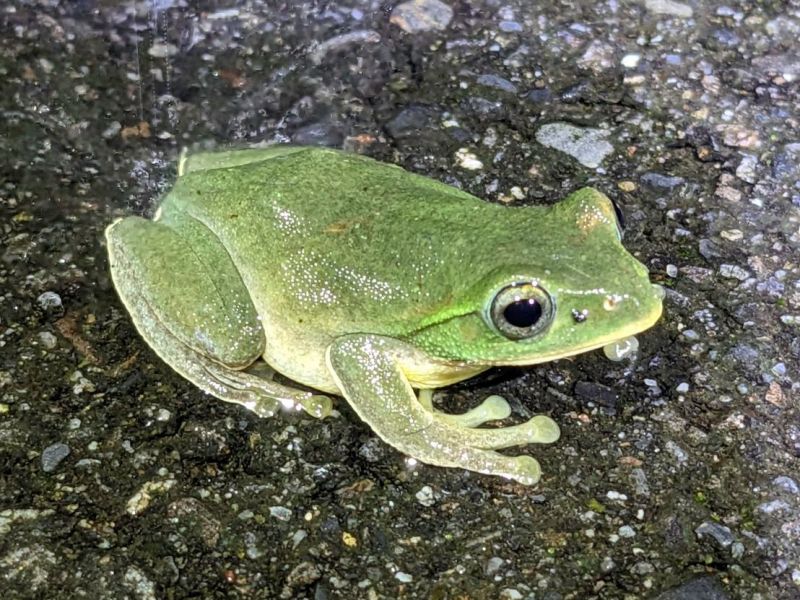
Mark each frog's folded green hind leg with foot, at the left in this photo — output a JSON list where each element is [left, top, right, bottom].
[[106, 215, 330, 416]]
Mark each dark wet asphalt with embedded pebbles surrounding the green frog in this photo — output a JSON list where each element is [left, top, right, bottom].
[[0, 0, 800, 600]]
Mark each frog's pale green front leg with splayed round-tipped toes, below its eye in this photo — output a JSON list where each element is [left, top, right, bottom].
[[327, 334, 558, 485]]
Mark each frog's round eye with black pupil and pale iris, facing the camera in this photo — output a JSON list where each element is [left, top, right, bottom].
[[489, 281, 553, 340]]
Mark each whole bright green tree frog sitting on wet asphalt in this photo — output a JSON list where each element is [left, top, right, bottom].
[[106, 146, 662, 484]]
